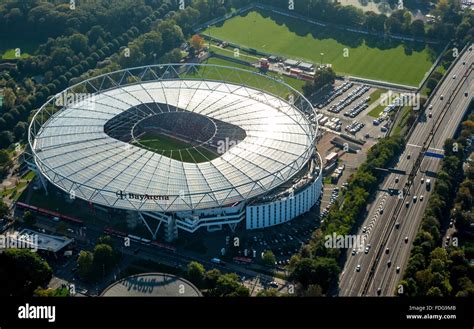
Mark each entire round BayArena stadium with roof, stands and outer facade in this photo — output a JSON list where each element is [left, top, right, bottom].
[[28, 64, 322, 241]]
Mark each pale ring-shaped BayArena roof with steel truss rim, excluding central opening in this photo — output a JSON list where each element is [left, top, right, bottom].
[[28, 64, 317, 212]]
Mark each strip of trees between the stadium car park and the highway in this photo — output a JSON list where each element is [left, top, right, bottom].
[[289, 136, 404, 294]]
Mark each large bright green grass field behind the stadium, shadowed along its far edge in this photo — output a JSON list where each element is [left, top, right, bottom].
[[203, 11, 443, 86]]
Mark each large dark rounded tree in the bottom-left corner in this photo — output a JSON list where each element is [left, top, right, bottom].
[[0, 249, 53, 297]]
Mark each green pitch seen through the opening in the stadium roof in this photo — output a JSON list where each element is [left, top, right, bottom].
[[134, 134, 219, 163]]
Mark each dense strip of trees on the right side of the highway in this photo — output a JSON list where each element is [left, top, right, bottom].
[[399, 114, 474, 296]]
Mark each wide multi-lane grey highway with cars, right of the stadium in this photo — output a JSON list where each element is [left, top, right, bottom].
[[339, 42, 474, 296]]
